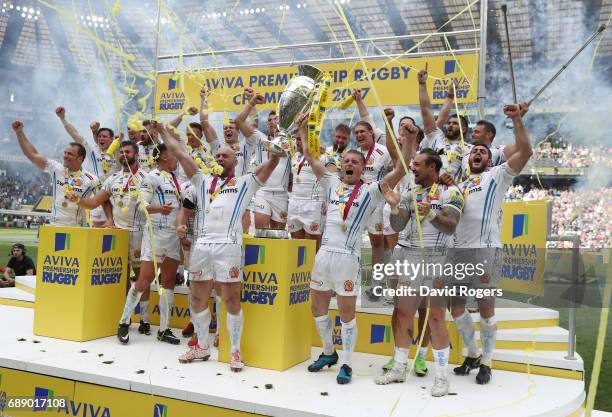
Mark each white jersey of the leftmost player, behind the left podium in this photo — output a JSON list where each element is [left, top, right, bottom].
[[44, 159, 100, 226]]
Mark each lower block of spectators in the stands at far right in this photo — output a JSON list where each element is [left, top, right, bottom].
[[506, 185, 612, 249]]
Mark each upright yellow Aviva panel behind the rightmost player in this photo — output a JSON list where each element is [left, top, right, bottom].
[[500, 200, 548, 296]]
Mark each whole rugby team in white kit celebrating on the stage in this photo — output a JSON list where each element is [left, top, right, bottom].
[[12, 69, 532, 396]]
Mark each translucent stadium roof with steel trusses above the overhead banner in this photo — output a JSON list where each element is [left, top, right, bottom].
[[0, 0, 612, 75]]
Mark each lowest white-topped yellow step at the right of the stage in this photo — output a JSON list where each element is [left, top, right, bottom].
[[462, 348, 584, 380]]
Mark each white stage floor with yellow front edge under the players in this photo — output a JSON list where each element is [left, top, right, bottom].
[[0, 302, 584, 417]]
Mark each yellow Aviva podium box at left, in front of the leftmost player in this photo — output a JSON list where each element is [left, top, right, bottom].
[[34, 226, 129, 341]]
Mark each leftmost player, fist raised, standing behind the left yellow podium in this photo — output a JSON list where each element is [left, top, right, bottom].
[[12, 120, 100, 226]]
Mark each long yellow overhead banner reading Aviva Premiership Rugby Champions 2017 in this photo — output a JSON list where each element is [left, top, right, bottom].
[[155, 54, 478, 114]]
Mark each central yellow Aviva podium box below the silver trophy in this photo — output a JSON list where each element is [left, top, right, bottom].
[[219, 238, 316, 371]]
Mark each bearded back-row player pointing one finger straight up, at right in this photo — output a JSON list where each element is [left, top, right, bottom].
[[417, 64, 468, 185]]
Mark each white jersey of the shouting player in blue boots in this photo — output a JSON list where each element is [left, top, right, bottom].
[[319, 172, 384, 256]]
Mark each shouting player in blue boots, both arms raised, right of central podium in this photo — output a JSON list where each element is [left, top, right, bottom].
[[299, 117, 417, 384]]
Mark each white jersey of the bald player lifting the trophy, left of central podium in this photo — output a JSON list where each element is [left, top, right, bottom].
[[191, 172, 263, 244]]
